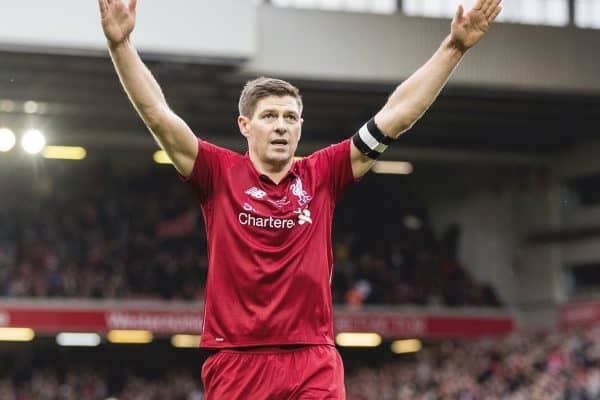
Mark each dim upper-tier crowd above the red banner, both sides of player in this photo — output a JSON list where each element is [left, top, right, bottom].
[[0, 163, 500, 306]]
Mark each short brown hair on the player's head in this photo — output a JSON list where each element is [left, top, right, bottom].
[[238, 76, 302, 118]]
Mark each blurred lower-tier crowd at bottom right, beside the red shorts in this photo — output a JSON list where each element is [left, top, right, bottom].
[[346, 329, 600, 400]]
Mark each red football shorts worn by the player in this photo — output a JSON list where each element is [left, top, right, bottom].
[[202, 345, 346, 400]]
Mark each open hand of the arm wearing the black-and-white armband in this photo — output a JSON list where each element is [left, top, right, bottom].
[[452, 0, 502, 50]]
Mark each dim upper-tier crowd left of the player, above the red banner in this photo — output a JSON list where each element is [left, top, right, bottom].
[[0, 162, 207, 300]]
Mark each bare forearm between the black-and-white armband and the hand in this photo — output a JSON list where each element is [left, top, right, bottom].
[[375, 37, 464, 138]]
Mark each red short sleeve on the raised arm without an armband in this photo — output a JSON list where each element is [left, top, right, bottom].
[[181, 139, 232, 202]]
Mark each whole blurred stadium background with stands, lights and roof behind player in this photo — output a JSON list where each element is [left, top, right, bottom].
[[0, 0, 600, 400]]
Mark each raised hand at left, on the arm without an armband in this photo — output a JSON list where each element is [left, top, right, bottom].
[[98, 0, 137, 47]]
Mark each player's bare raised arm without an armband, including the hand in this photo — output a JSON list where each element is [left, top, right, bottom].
[[98, 0, 198, 177]]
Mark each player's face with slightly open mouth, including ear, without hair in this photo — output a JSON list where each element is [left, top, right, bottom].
[[238, 96, 303, 168]]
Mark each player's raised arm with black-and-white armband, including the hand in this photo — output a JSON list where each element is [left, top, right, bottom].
[[350, 0, 502, 177]]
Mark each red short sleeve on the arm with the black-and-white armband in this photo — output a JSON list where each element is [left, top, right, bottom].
[[310, 139, 356, 202]]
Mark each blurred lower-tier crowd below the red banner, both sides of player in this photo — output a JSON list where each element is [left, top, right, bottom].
[[0, 328, 600, 400]]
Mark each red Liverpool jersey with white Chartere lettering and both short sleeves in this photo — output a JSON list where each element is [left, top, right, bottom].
[[188, 140, 354, 348]]
